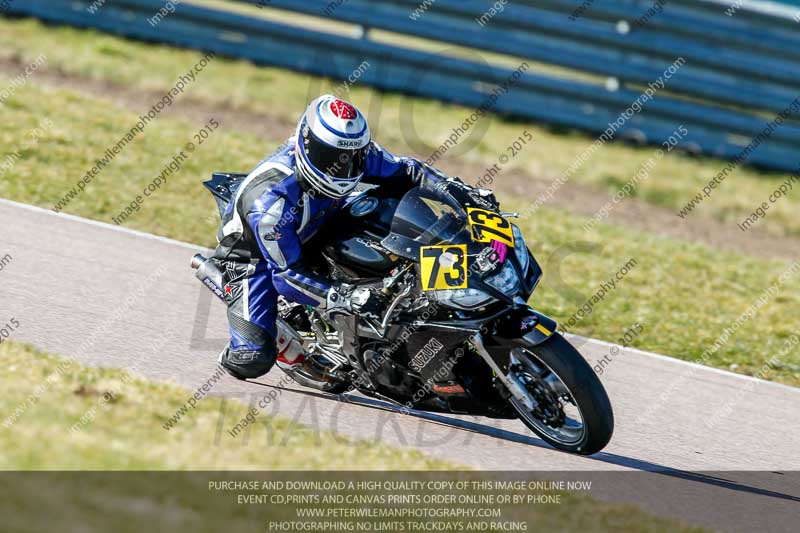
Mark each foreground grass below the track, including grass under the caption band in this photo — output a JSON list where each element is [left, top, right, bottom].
[[0, 342, 712, 533]]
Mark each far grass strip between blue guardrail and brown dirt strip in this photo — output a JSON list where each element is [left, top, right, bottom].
[[0, 15, 800, 235]]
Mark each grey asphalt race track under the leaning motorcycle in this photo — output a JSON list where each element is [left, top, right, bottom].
[[0, 200, 800, 531]]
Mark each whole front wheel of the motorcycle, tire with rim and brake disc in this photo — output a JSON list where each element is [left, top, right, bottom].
[[508, 333, 614, 455]]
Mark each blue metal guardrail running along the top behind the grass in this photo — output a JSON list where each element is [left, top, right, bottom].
[[8, 0, 800, 171]]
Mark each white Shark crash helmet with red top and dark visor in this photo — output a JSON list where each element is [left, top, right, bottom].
[[295, 94, 370, 198]]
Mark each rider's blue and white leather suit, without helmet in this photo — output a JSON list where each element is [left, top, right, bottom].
[[217, 138, 435, 373]]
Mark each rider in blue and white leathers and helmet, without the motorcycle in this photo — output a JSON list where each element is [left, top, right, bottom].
[[213, 95, 468, 379]]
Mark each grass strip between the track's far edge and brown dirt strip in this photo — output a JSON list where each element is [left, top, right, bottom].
[[0, 80, 800, 385]]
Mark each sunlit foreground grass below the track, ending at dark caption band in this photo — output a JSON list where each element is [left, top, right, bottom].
[[0, 342, 455, 470]]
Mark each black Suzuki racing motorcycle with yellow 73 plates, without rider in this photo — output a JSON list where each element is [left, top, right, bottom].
[[193, 173, 614, 455]]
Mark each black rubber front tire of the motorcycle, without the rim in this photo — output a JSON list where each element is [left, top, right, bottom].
[[509, 333, 614, 455]]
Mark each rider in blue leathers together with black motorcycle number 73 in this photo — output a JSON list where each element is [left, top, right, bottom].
[[191, 95, 614, 455]]
